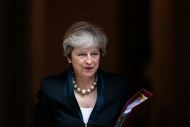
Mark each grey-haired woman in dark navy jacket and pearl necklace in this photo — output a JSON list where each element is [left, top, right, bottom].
[[36, 21, 131, 127]]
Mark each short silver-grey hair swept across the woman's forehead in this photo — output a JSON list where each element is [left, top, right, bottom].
[[63, 21, 108, 57]]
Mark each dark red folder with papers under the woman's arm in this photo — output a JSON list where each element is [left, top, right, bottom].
[[115, 88, 153, 127]]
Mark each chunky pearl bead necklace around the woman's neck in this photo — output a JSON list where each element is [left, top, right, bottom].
[[72, 73, 97, 96]]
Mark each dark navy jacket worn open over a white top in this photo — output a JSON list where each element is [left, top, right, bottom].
[[35, 68, 129, 127]]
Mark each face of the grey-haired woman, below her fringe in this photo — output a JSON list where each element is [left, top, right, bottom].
[[71, 48, 100, 77]]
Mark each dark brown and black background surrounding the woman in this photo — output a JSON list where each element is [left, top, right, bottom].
[[0, 0, 190, 127]]
